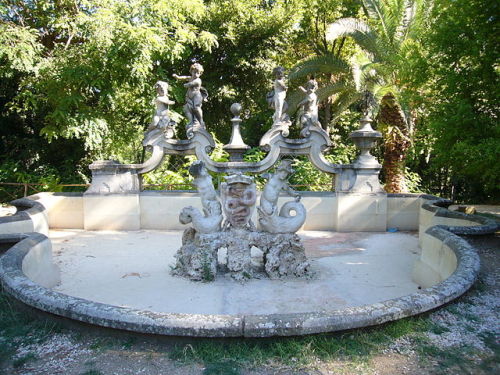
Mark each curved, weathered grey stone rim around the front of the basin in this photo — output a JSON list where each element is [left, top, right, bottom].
[[0, 227, 479, 337]]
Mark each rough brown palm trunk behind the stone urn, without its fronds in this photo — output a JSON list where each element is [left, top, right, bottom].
[[378, 93, 411, 193]]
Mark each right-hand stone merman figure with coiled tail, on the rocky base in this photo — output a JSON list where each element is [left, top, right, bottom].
[[257, 160, 306, 233]]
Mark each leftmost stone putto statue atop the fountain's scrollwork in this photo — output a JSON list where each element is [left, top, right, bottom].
[[145, 81, 175, 142]]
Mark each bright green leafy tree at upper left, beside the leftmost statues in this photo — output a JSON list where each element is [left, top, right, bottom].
[[0, 0, 217, 161]]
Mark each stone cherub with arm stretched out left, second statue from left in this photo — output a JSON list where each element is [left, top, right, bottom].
[[173, 63, 208, 134]]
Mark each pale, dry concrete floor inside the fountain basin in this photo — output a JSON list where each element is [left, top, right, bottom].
[[50, 230, 420, 315]]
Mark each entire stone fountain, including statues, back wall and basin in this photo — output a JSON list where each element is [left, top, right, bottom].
[[0, 63, 488, 337]]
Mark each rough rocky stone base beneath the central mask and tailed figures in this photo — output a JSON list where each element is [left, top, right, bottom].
[[172, 228, 310, 281]]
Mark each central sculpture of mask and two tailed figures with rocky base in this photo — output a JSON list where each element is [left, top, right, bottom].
[[173, 161, 309, 281]]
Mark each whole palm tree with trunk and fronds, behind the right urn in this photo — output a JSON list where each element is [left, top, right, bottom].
[[296, 0, 432, 193]]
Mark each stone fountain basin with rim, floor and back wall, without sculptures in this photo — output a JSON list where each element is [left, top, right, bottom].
[[0, 192, 499, 337]]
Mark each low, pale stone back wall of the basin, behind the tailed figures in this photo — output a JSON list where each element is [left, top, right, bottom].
[[0, 191, 434, 233]]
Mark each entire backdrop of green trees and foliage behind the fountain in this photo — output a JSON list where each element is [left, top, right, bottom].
[[0, 0, 500, 201]]
